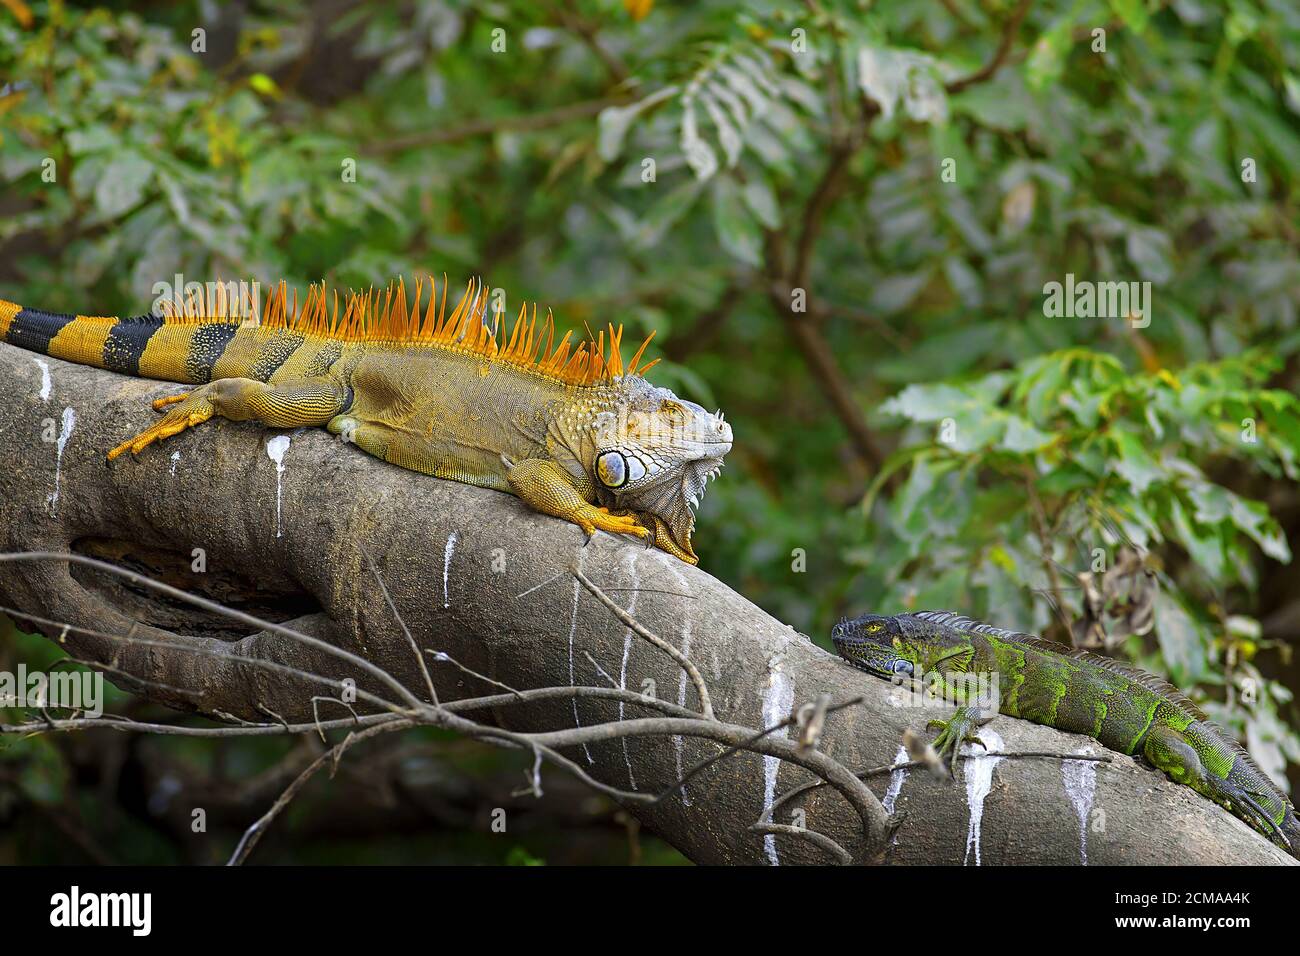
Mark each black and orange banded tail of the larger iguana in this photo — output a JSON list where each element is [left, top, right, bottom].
[[0, 299, 239, 385]]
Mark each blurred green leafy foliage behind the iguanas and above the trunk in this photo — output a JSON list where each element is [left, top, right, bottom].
[[0, 0, 1300, 862]]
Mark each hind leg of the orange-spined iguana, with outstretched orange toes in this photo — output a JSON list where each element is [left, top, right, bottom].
[[108, 378, 347, 460]]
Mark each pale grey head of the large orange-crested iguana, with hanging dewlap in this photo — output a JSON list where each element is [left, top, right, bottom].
[[582, 376, 732, 564]]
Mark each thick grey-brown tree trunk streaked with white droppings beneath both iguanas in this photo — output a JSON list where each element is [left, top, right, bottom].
[[0, 345, 1290, 864]]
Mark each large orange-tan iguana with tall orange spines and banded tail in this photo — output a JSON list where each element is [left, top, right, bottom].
[[0, 278, 732, 564]]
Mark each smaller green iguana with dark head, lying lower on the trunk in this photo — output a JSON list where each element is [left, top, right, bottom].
[[831, 611, 1300, 858]]
